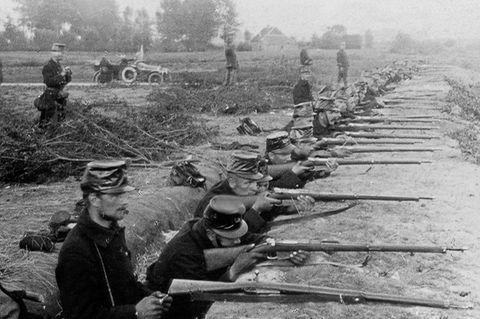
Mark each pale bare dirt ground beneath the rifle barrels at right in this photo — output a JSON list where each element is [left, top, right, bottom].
[[208, 66, 480, 319]]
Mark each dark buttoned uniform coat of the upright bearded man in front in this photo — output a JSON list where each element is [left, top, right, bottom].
[[55, 210, 150, 319]]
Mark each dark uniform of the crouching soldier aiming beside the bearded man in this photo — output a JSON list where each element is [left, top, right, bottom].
[[147, 219, 264, 319]]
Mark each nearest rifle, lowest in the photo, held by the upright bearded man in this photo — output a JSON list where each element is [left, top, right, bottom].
[[168, 279, 473, 309]]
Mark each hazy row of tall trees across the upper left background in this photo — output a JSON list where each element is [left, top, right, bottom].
[[0, 0, 238, 51]]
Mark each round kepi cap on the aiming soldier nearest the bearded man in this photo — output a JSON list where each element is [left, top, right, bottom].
[[203, 195, 248, 239]]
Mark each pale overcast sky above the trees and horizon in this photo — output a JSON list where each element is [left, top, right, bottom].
[[0, 0, 480, 40]]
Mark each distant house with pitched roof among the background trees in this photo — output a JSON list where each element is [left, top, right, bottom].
[[251, 26, 298, 52]]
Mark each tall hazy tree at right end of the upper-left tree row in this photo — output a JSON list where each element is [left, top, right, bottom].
[[157, 0, 222, 51]]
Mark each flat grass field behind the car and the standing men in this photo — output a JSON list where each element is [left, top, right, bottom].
[[0, 50, 408, 84]]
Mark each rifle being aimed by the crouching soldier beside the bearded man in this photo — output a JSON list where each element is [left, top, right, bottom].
[[203, 240, 466, 271]]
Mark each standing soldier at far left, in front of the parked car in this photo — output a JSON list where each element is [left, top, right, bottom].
[[40, 43, 72, 127]]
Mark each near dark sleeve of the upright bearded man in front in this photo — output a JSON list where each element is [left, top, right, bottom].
[[55, 251, 139, 319]]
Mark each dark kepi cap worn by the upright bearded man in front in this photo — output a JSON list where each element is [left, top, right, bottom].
[[80, 160, 135, 194]]
